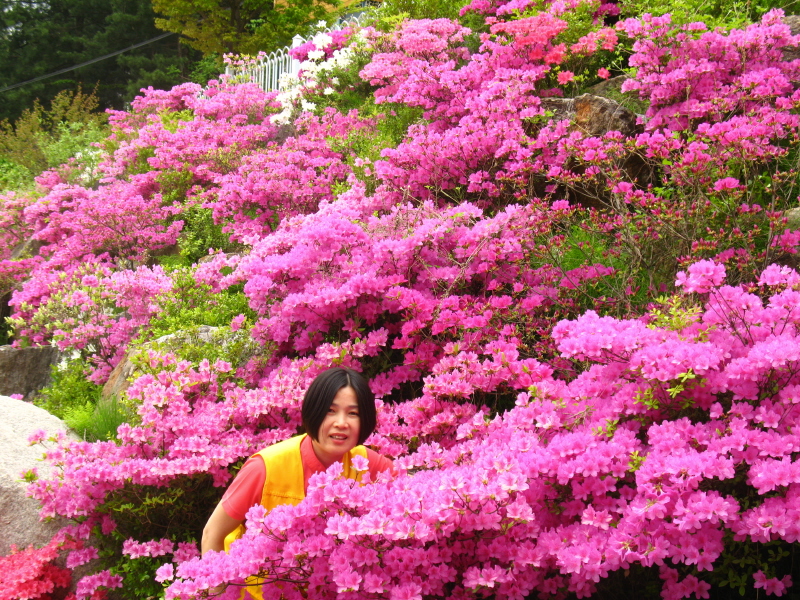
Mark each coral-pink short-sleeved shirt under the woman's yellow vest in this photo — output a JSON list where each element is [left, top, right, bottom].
[[222, 436, 392, 521]]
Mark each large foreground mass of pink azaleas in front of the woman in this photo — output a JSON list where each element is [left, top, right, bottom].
[[159, 272, 800, 599]]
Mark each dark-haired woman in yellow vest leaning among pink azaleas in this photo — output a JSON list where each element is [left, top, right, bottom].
[[201, 368, 392, 564]]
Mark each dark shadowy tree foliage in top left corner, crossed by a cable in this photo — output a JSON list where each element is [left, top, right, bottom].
[[0, 0, 205, 120]]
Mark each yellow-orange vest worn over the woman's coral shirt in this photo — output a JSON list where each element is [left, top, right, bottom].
[[225, 434, 367, 600]]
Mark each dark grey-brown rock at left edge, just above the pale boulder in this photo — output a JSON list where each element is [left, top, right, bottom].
[[0, 346, 59, 399]]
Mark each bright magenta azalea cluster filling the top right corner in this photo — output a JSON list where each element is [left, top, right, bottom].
[[618, 10, 800, 131]]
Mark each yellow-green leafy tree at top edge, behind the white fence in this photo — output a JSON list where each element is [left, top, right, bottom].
[[153, 0, 339, 54]]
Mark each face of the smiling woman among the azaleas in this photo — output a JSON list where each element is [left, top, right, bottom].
[[311, 387, 361, 467]]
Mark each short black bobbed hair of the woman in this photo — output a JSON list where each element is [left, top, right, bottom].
[[301, 367, 377, 444]]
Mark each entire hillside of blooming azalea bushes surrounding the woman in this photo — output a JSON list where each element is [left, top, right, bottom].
[[0, 0, 800, 600]]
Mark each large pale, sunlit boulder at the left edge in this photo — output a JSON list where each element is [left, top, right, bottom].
[[0, 396, 77, 556]]
